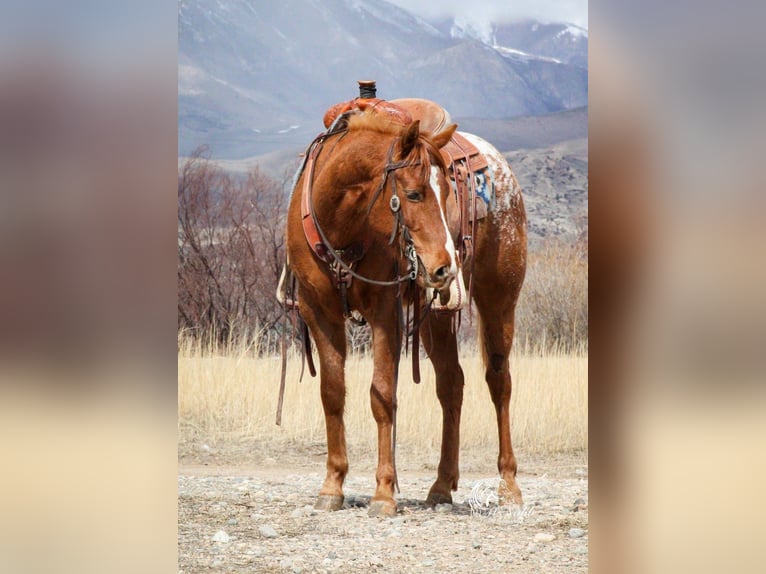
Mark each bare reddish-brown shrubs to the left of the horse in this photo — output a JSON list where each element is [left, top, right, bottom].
[[178, 148, 287, 343]]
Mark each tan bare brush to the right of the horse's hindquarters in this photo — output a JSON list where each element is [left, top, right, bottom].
[[516, 237, 588, 351]]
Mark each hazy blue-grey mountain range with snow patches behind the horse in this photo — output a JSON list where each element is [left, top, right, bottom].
[[178, 0, 588, 158]]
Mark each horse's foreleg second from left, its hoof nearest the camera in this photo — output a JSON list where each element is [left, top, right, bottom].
[[369, 313, 399, 516]]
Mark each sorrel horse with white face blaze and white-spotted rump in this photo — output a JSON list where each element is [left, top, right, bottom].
[[287, 98, 526, 516]]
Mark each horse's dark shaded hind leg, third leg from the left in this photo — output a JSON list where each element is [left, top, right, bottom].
[[421, 314, 464, 505]]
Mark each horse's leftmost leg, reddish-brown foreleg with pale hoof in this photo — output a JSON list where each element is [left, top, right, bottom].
[[301, 302, 348, 510]]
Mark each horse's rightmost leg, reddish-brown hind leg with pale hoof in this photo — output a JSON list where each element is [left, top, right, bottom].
[[477, 304, 522, 504]]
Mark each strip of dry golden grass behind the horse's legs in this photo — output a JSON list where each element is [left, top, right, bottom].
[[178, 341, 588, 464]]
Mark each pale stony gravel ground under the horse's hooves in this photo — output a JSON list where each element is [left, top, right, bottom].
[[178, 456, 588, 574]]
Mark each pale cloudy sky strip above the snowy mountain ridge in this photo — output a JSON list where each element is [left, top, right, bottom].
[[389, 0, 588, 28]]
